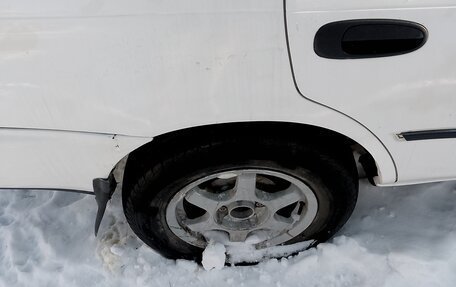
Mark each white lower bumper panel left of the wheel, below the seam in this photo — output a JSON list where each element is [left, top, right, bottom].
[[0, 129, 151, 192]]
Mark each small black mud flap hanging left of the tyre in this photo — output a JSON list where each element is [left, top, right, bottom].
[[93, 177, 117, 236]]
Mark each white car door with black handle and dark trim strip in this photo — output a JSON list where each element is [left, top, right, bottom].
[[285, 0, 456, 183]]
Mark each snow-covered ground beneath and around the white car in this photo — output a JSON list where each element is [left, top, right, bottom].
[[0, 182, 456, 287]]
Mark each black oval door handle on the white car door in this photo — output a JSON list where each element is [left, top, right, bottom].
[[314, 19, 428, 59]]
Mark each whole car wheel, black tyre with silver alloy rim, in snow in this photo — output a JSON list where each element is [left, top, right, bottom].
[[123, 127, 358, 263]]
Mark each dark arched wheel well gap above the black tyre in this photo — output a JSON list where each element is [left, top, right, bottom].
[[122, 122, 377, 196]]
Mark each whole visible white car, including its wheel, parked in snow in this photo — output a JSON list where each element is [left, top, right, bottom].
[[0, 0, 456, 262]]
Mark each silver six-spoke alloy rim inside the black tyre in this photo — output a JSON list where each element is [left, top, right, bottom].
[[166, 169, 318, 249]]
